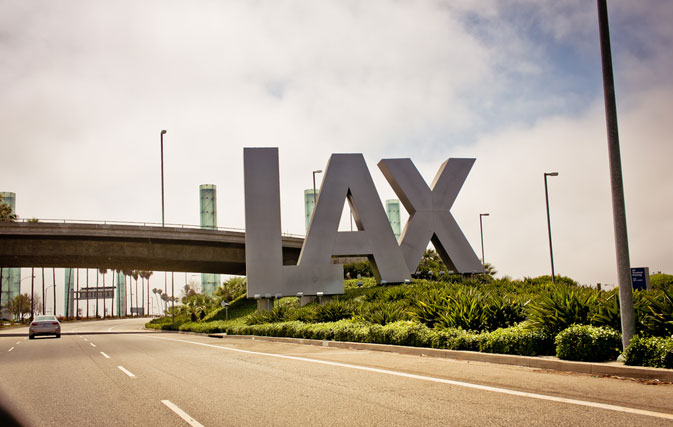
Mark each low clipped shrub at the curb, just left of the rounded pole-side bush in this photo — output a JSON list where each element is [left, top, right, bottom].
[[477, 325, 554, 356]]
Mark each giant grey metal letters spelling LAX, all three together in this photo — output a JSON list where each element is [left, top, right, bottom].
[[243, 148, 483, 298]]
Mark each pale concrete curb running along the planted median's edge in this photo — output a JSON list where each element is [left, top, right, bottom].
[[206, 334, 673, 382]]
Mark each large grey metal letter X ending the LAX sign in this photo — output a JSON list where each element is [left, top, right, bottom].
[[378, 159, 484, 273]]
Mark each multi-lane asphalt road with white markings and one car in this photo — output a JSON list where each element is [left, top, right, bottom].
[[0, 319, 673, 426]]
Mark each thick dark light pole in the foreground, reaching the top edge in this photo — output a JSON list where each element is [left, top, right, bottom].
[[597, 0, 636, 348]]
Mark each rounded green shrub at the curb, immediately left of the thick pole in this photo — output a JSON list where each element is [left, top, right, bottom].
[[554, 325, 622, 362]]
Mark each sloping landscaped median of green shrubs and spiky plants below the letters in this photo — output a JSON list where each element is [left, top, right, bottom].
[[147, 277, 673, 369]]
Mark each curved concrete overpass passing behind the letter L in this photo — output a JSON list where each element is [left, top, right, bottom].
[[0, 222, 304, 275]]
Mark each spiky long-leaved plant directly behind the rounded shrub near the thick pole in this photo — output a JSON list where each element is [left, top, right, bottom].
[[528, 285, 598, 335]]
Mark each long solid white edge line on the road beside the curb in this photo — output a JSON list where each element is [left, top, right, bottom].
[[148, 335, 673, 420]]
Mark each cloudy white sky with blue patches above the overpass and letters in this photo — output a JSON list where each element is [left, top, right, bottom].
[[0, 0, 673, 290]]
